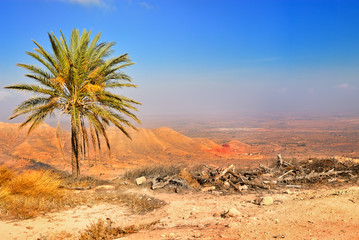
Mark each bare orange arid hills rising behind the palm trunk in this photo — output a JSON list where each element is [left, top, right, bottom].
[[0, 123, 258, 174]]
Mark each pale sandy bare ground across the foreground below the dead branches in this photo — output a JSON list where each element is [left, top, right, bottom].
[[0, 186, 359, 240]]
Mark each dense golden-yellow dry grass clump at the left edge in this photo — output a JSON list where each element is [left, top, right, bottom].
[[0, 166, 67, 218]]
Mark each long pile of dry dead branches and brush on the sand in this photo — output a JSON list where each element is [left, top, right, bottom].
[[143, 154, 359, 191]]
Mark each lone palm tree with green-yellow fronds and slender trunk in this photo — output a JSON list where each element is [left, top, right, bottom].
[[5, 29, 140, 178]]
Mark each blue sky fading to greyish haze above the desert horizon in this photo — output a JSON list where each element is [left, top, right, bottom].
[[0, 0, 359, 124]]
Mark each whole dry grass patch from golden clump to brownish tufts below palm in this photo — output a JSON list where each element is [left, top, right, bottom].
[[0, 166, 168, 218]]
